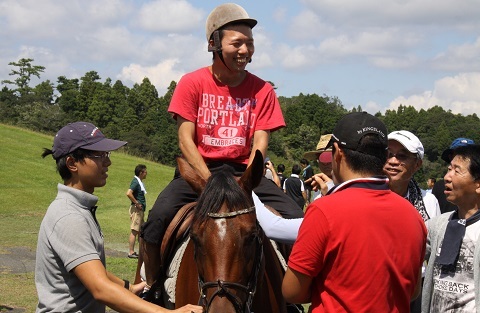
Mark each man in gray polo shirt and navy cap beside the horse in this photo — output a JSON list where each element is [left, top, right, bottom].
[[35, 122, 202, 313]]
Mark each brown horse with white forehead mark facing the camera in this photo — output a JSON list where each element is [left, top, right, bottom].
[[171, 151, 287, 313]]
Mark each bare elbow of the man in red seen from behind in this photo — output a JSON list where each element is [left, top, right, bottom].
[[282, 268, 312, 303]]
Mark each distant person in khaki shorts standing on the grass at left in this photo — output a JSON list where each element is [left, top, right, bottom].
[[127, 164, 147, 259]]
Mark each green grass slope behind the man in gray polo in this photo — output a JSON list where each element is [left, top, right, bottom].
[[0, 124, 173, 312]]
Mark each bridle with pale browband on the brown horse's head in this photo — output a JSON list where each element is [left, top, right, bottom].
[[198, 206, 263, 313]]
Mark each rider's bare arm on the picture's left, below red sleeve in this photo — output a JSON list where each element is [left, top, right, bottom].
[[177, 116, 210, 180]]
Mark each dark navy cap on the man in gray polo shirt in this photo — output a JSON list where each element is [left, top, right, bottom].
[[52, 122, 127, 160]]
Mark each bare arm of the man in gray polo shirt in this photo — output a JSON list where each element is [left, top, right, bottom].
[[73, 260, 203, 313]]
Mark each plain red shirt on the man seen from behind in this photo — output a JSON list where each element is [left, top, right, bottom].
[[288, 178, 426, 313]]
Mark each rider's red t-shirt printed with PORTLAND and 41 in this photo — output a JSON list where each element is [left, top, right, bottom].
[[168, 67, 285, 164]]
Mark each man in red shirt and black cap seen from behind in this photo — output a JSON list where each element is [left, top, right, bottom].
[[282, 112, 426, 313]]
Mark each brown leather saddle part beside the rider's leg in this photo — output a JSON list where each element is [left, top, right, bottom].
[[160, 202, 197, 271]]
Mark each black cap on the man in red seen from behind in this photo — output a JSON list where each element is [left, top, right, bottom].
[[326, 112, 388, 154]]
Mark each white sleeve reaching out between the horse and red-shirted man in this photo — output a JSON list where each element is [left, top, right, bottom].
[[252, 192, 303, 244]]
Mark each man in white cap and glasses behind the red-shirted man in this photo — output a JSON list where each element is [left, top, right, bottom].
[[383, 130, 441, 313]]
